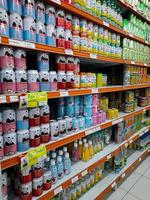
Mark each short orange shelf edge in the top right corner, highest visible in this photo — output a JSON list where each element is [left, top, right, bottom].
[[118, 0, 150, 24]]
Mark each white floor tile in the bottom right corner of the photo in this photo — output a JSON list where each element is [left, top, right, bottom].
[[129, 177, 150, 200]]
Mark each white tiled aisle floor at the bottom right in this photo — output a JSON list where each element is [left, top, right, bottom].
[[107, 156, 150, 200]]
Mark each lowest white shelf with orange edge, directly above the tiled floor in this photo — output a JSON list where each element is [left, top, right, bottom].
[[80, 149, 149, 200]]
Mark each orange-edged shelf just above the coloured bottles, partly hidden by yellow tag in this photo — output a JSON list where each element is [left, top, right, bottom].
[[1, 106, 150, 169]]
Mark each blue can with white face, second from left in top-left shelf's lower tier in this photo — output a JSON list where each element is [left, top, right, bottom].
[[9, 12, 23, 40]]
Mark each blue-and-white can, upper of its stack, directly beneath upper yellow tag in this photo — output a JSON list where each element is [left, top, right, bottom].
[[16, 109, 29, 130]]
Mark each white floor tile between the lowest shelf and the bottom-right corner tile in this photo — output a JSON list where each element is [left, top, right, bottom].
[[120, 173, 141, 191]]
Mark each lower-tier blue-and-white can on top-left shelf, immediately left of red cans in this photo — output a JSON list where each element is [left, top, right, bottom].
[[46, 24, 56, 47]]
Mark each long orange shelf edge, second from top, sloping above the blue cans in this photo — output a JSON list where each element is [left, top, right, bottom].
[[44, 0, 150, 46]]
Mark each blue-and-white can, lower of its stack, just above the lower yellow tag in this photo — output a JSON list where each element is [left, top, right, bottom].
[[17, 129, 30, 152]]
